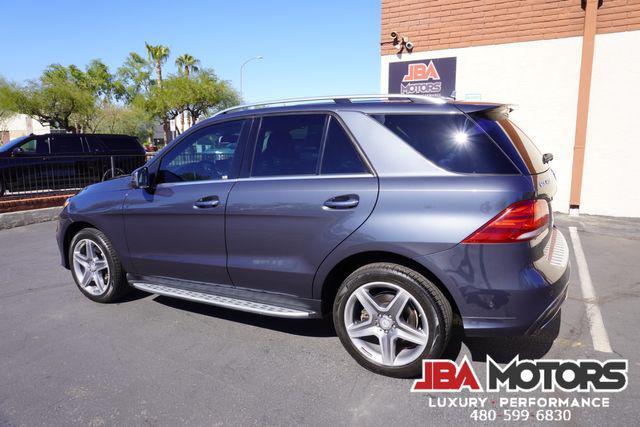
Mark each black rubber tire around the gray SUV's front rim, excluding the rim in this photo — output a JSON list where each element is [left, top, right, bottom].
[[67, 228, 132, 303]]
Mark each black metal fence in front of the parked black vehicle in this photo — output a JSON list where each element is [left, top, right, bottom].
[[0, 155, 146, 200]]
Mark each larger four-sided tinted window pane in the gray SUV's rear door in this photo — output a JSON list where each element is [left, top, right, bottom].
[[251, 114, 326, 176]]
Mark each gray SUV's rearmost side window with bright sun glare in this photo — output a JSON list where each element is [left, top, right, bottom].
[[373, 114, 519, 174]]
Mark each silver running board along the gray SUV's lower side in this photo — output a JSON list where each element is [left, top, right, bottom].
[[130, 282, 315, 318]]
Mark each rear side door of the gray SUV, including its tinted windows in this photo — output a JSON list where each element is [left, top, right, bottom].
[[226, 113, 378, 298]]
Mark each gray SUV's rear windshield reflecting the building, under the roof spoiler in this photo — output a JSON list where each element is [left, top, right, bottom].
[[472, 115, 549, 174]]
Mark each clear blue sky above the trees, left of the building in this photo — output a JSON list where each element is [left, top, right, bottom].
[[0, 0, 380, 101]]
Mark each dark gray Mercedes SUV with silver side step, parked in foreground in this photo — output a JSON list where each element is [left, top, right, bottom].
[[58, 95, 569, 377]]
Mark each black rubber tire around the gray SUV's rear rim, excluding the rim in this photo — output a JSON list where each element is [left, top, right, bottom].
[[333, 263, 453, 378]]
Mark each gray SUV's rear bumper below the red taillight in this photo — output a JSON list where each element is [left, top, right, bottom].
[[418, 228, 571, 336]]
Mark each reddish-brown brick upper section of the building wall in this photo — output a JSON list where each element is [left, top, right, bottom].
[[381, 0, 640, 55]]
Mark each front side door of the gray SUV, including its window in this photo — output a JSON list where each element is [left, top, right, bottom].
[[124, 120, 251, 285]]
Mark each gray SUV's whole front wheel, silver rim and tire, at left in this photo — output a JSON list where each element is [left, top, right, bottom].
[[69, 228, 131, 302]]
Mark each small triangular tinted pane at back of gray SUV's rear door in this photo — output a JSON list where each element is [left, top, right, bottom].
[[321, 118, 366, 174]]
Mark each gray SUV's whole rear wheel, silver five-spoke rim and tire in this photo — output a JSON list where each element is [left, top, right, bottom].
[[333, 263, 453, 378]]
